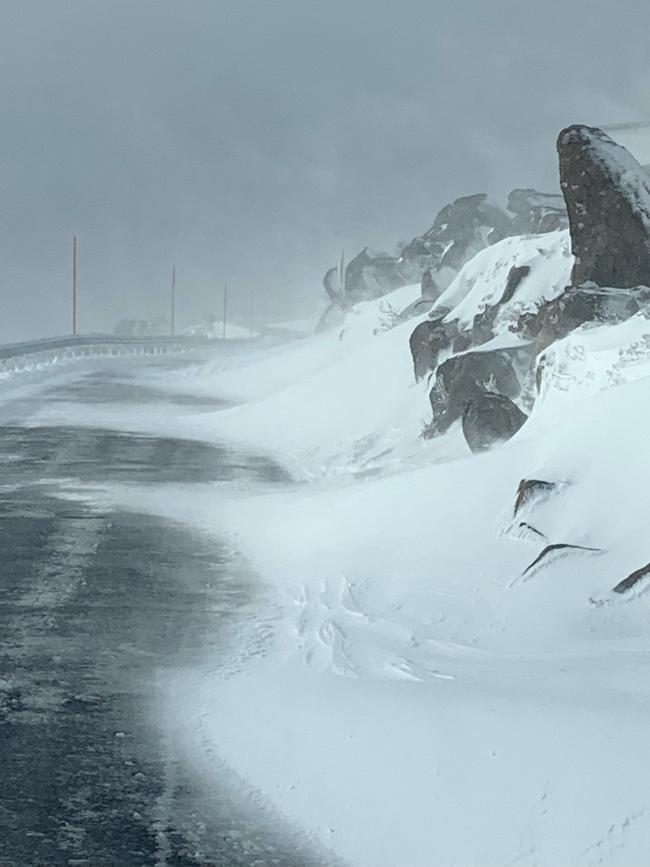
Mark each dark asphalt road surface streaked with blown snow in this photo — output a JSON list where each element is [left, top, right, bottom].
[[0, 350, 334, 867]]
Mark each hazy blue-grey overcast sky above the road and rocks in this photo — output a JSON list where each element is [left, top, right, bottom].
[[0, 0, 650, 341]]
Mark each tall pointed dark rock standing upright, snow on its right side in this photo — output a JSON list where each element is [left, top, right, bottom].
[[557, 125, 650, 288]]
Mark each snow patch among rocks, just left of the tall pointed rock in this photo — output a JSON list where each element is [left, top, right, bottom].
[[436, 230, 573, 330]]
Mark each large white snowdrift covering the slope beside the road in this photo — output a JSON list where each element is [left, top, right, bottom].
[[30, 268, 650, 867]]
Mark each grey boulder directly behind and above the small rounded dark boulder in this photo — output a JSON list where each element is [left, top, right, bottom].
[[429, 350, 521, 433]]
